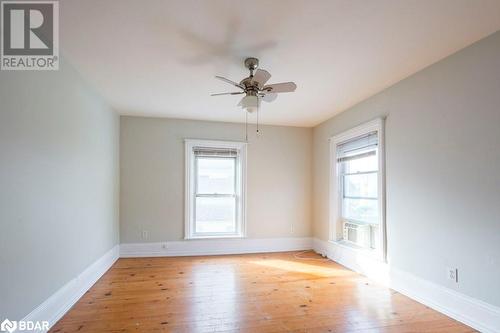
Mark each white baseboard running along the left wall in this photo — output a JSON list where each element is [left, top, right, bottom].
[[20, 245, 120, 332]]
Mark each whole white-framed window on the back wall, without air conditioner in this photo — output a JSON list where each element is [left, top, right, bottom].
[[185, 140, 246, 239]]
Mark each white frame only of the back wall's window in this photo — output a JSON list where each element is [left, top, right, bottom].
[[184, 139, 247, 239]]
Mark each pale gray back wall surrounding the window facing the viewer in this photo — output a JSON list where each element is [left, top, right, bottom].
[[120, 117, 312, 243]]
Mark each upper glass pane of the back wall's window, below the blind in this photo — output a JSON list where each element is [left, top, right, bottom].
[[197, 157, 236, 194]]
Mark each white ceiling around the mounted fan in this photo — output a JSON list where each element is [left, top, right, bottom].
[[60, 0, 500, 126]]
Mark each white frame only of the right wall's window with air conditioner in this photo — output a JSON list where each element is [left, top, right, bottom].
[[329, 118, 387, 261]]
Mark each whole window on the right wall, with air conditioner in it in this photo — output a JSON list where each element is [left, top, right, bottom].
[[331, 119, 385, 258]]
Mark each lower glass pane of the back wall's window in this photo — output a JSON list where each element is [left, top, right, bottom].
[[195, 197, 236, 233]]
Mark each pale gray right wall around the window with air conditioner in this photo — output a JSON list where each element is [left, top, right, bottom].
[[313, 33, 500, 306]]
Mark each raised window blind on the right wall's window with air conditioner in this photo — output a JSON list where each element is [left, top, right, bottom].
[[337, 131, 378, 162]]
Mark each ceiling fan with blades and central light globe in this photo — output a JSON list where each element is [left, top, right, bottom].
[[211, 58, 297, 112]]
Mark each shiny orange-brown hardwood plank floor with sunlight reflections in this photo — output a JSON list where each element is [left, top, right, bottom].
[[50, 252, 475, 333]]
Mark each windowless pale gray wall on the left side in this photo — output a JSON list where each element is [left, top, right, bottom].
[[0, 62, 119, 320]]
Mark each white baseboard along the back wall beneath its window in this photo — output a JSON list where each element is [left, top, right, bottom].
[[120, 237, 313, 258]]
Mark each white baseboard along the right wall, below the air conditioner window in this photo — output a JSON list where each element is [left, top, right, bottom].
[[313, 238, 500, 333]]
